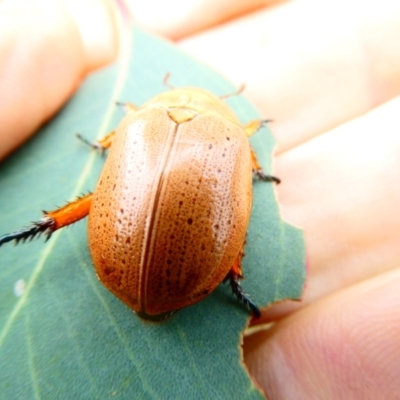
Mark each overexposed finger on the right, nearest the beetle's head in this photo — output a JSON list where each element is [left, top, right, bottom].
[[179, 0, 400, 152]]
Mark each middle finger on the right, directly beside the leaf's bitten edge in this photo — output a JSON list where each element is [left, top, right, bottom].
[[275, 97, 400, 310]]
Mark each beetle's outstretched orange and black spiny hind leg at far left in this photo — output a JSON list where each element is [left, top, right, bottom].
[[0, 193, 92, 246]]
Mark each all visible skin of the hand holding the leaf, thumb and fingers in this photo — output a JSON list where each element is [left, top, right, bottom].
[[0, 0, 400, 400]]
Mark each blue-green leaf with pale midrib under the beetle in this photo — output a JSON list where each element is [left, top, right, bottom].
[[0, 29, 305, 399]]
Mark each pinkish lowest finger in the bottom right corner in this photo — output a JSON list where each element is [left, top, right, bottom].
[[244, 270, 400, 400]]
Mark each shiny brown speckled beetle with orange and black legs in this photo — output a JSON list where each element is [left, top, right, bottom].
[[0, 83, 279, 320]]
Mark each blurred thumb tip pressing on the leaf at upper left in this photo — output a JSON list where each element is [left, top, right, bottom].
[[0, 0, 117, 159]]
